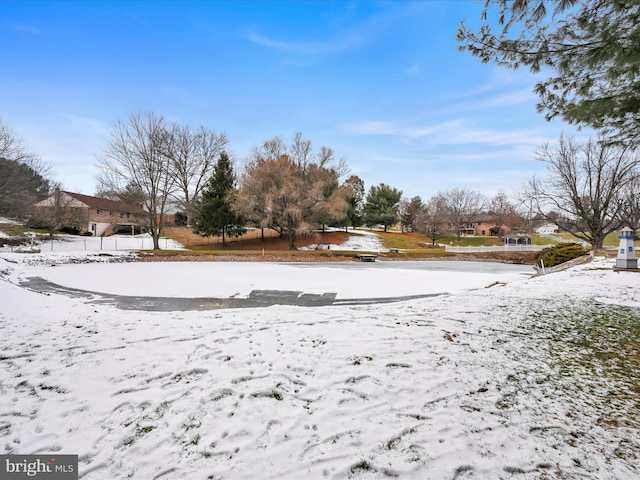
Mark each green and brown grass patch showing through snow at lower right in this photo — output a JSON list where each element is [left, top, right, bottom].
[[529, 303, 640, 428]]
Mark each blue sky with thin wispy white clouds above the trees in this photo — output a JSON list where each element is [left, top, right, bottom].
[[0, 0, 585, 200]]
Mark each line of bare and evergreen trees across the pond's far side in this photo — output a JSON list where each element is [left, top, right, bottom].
[[0, 112, 640, 249]]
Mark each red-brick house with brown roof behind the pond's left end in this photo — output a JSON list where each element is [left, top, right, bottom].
[[34, 189, 148, 236]]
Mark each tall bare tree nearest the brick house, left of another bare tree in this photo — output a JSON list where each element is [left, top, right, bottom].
[[99, 112, 175, 250]]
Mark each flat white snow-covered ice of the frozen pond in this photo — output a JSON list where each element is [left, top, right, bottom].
[[21, 261, 534, 303]]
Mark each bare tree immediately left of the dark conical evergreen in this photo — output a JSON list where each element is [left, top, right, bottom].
[[167, 125, 228, 225]]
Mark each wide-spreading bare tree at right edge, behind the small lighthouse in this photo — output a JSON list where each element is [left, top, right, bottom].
[[527, 137, 640, 250]]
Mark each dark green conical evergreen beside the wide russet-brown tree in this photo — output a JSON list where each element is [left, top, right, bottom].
[[193, 152, 246, 246]]
